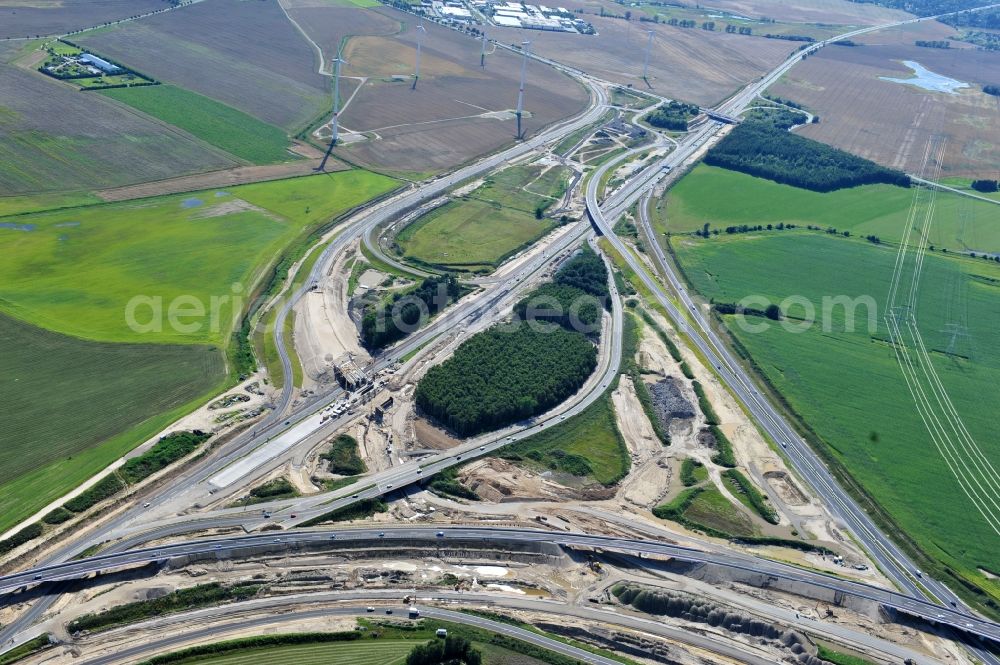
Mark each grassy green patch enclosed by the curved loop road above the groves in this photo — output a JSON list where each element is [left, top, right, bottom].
[[396, 166, 568, 271]]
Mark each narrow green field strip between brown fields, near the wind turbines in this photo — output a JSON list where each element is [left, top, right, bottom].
[[101, 85, 294, 164]]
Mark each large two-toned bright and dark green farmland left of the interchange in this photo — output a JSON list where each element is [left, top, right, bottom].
[[0, 171, 395, 529]]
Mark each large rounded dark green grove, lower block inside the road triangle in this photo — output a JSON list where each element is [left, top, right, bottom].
[[416, 322, 597, 436]]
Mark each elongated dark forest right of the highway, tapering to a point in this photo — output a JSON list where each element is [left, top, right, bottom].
[[705, 121, 910, 192]]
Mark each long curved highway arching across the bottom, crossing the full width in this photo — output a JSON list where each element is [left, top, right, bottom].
[[7, 526, 1000, 645]]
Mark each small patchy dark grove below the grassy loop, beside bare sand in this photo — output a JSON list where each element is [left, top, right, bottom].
[[361, 275, 461, 349]]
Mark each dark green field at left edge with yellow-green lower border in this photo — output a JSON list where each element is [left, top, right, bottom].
[[0, 315, 225, 531]]
